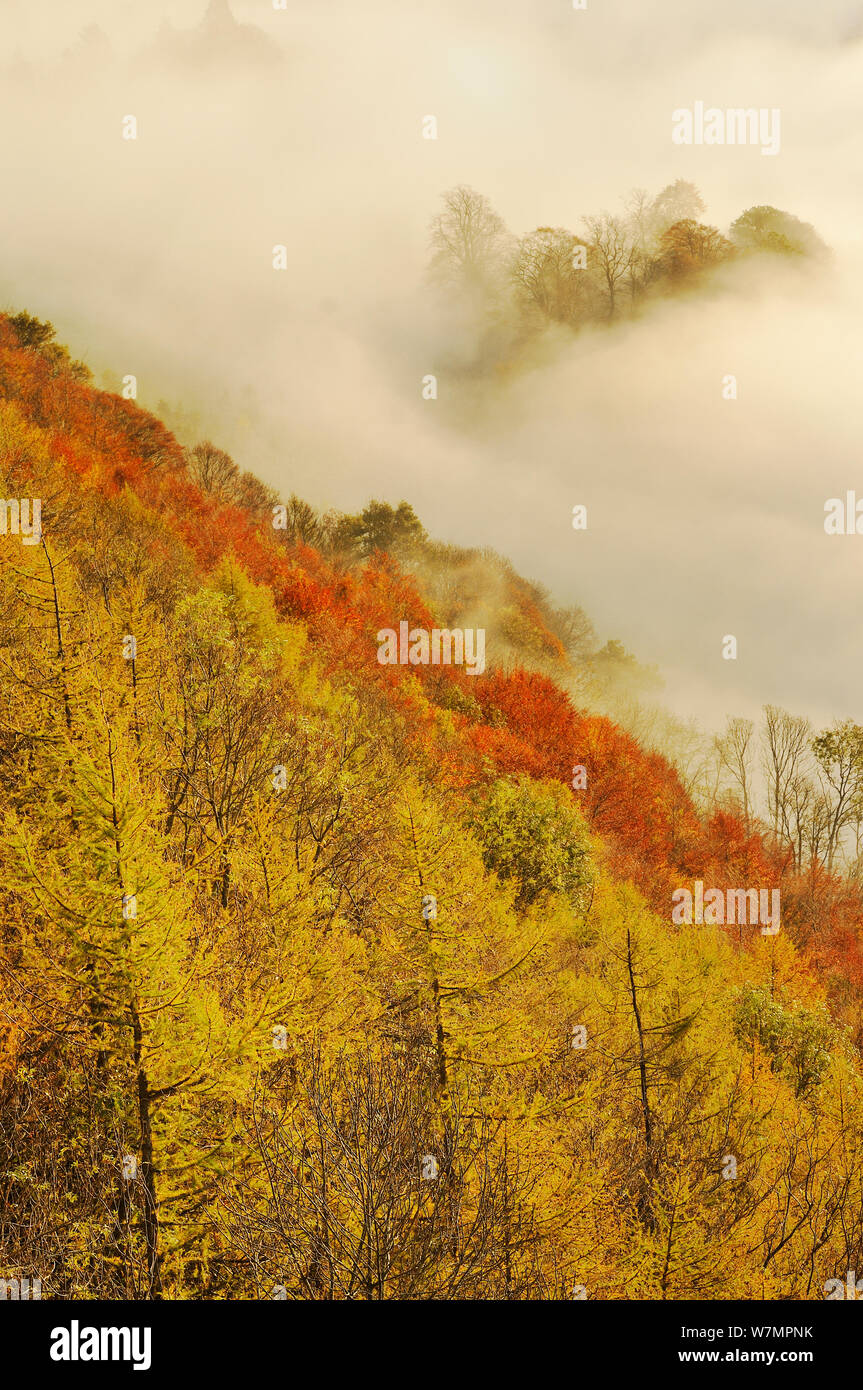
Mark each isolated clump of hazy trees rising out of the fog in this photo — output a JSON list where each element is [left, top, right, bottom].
[[429, 179, 828, 336]]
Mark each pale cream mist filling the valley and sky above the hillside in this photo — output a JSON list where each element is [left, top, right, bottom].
[[0, 0, 863, 727]]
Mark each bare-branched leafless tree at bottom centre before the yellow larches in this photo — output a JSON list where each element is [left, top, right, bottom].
[[222, 1049, 548, 1300]]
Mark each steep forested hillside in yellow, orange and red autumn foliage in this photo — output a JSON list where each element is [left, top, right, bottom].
[[0, 307, 863, 1300]]
